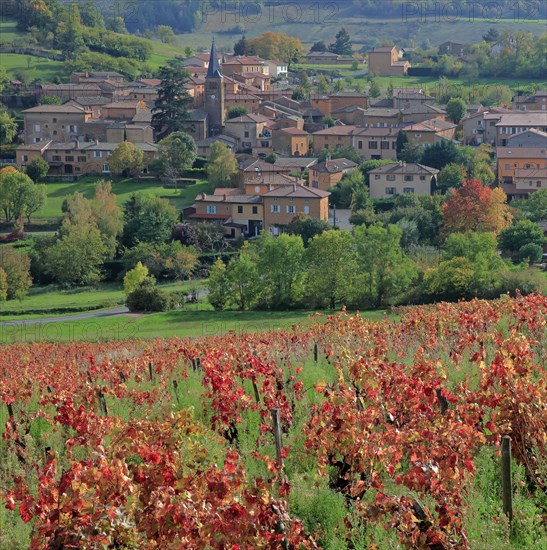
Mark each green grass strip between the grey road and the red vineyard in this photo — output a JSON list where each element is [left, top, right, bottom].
[[0, 303, 395, 344]]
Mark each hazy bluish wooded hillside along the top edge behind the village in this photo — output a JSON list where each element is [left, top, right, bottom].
[[90, 0, 547, 38]]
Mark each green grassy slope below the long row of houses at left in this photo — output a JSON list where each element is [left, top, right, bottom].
[[33, 176, 211, 219]]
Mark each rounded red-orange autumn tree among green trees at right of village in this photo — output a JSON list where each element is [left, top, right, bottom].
[[442, 179, 513, 234]]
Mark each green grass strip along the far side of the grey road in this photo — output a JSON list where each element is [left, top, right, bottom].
[[0, 280, 205, 321]]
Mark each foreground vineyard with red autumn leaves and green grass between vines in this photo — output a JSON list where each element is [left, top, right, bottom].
[[0, 295, 547, 550]]
